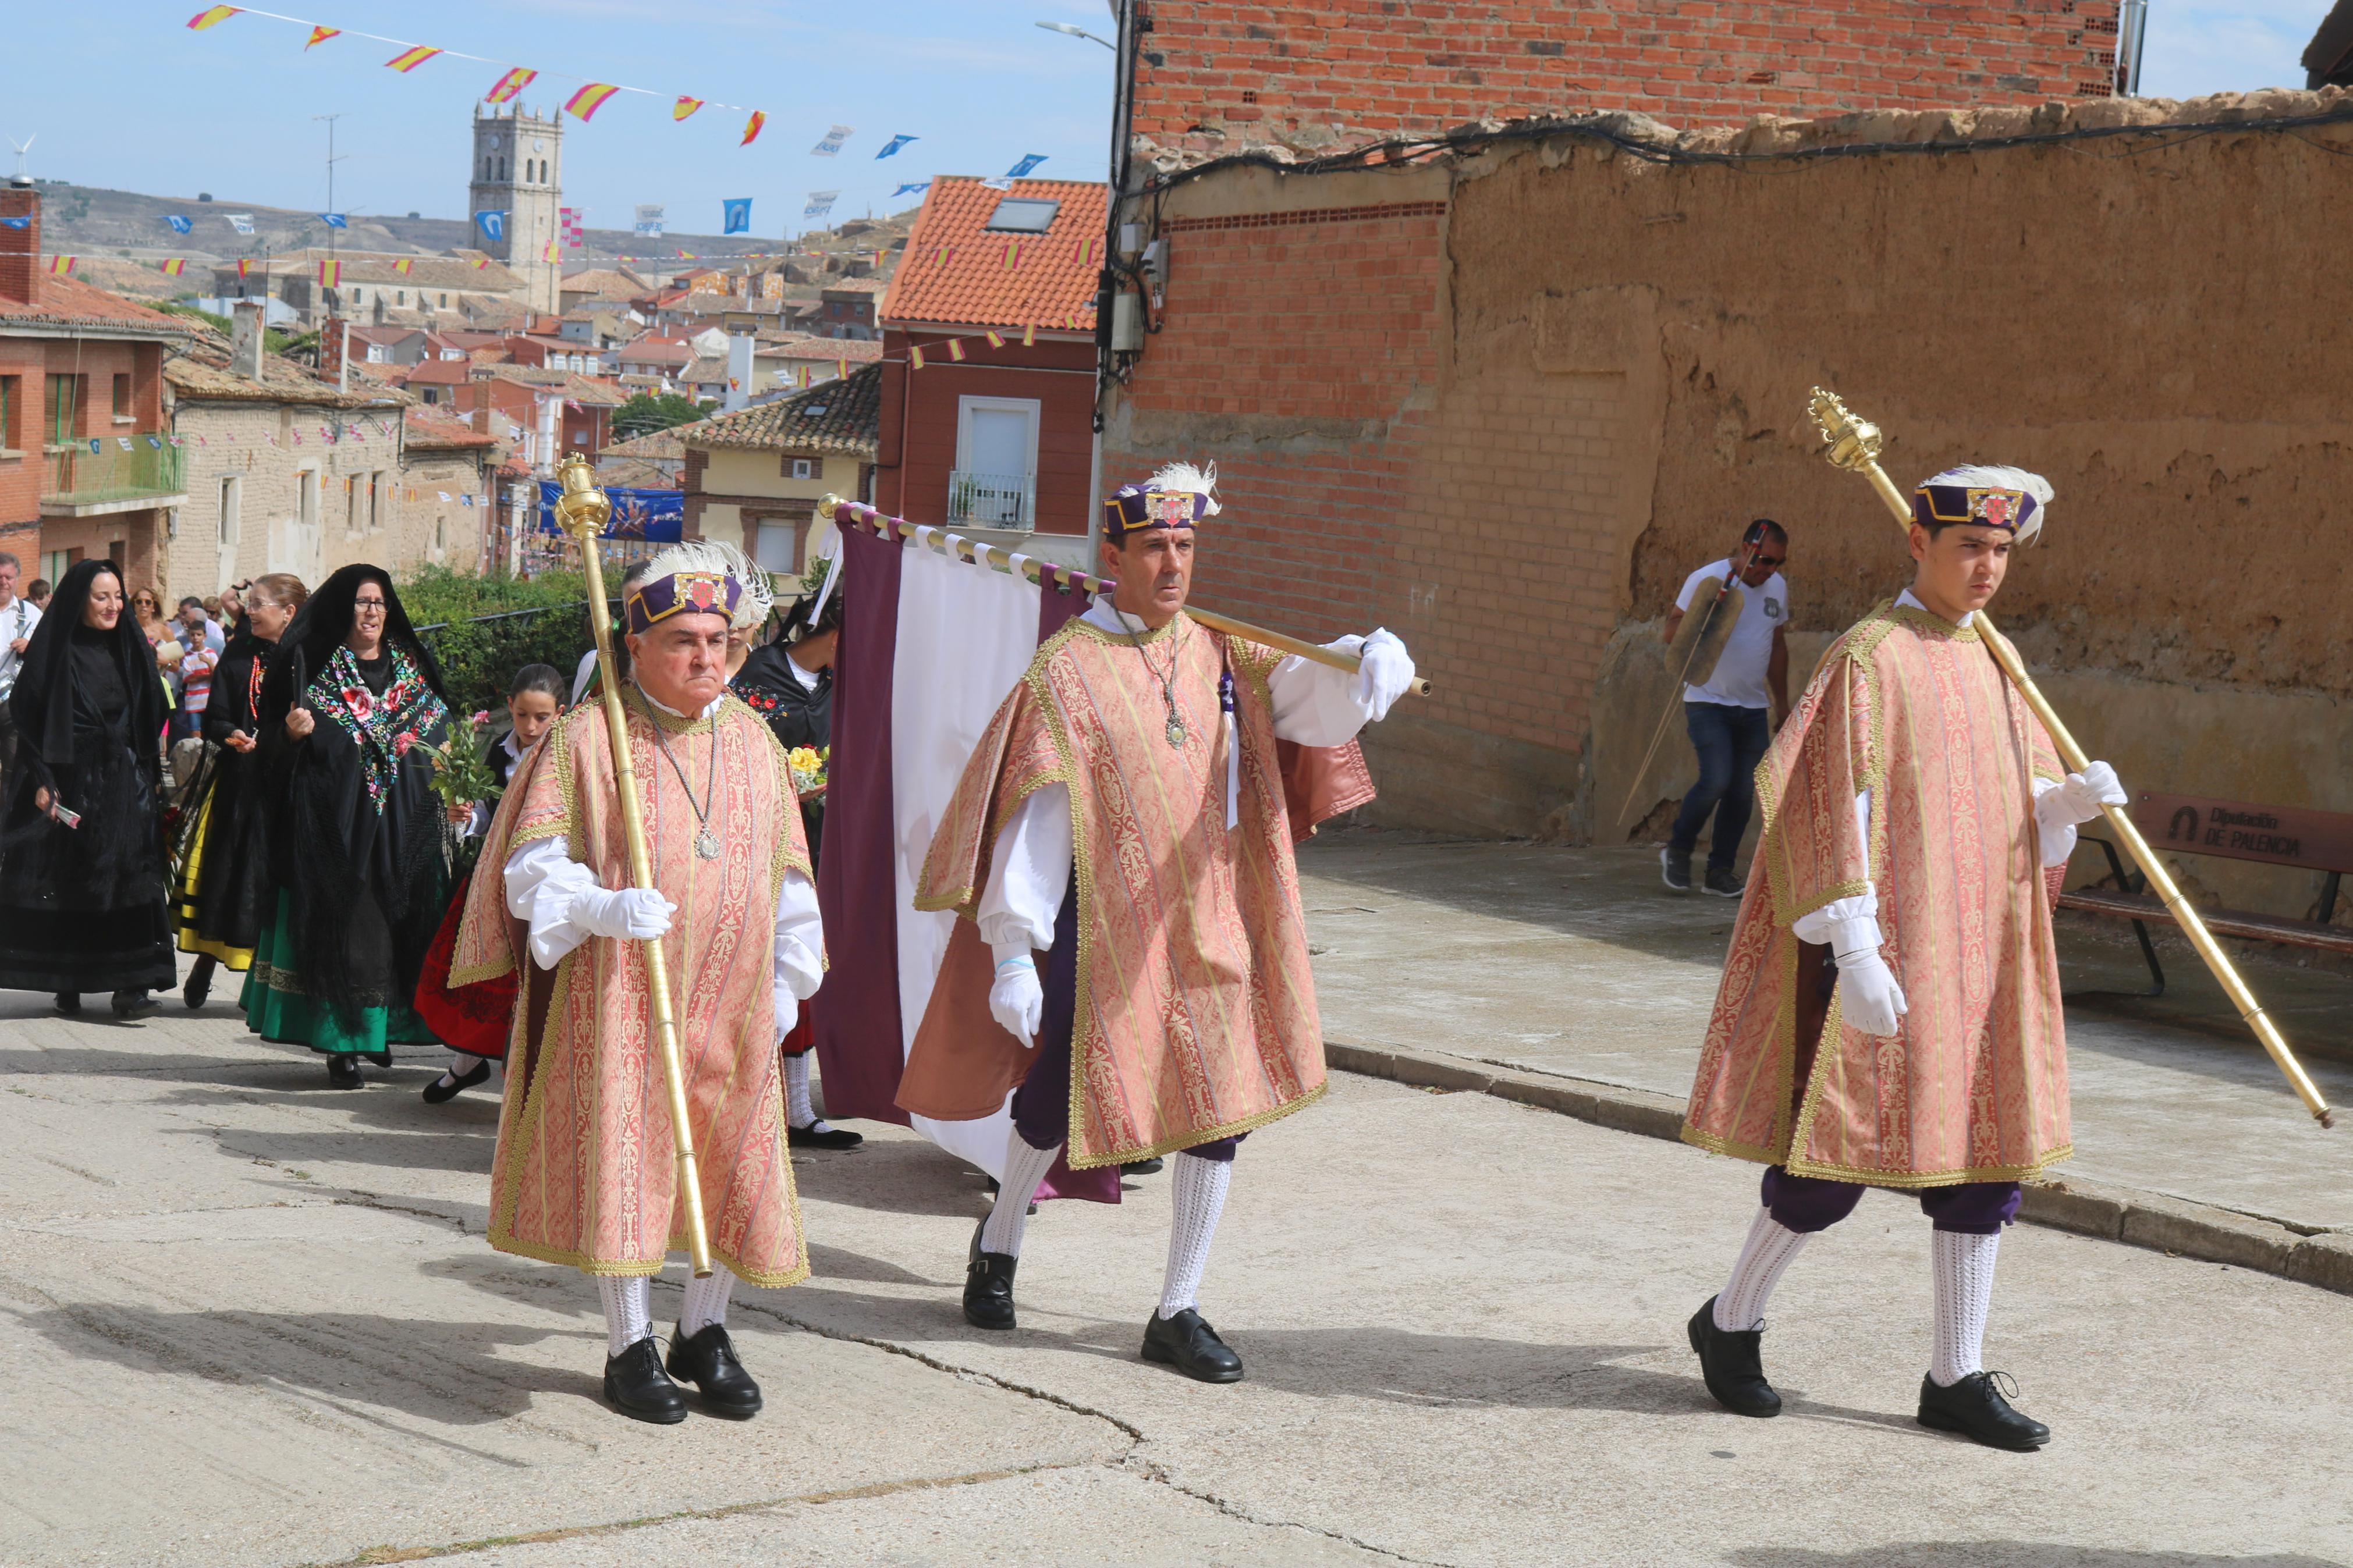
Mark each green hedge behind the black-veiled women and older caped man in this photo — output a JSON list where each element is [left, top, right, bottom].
[[400, 567, 595, 717]]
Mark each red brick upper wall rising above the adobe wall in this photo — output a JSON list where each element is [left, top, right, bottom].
[[1134, 0, 2116, 155]]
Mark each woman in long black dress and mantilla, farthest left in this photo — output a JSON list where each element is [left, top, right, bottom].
[[0, 560, 176, 1018]]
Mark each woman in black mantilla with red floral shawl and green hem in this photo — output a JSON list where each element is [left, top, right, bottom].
[[242, 567, 449, 1089]]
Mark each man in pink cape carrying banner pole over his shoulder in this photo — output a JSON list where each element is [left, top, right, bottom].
[[899, 463, 1414, 1382]]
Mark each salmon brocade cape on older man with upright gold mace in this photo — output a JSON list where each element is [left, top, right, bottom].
[[452, 689, 810, 1286]]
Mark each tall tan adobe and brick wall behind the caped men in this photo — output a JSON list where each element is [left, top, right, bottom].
[[1106, 90, 2353, 907]]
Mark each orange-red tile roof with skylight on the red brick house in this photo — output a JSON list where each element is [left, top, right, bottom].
[[875, 176, 1108, 332]]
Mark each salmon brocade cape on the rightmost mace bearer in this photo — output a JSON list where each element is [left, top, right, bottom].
[[1683, 604, 2073, 1187]]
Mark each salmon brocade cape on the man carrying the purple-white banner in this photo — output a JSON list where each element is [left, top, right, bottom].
[[899, 614, 1372, 1168]]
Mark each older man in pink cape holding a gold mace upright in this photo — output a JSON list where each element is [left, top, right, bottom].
[[452, 545, 824, 1425]]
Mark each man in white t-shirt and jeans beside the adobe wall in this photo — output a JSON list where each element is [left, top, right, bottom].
[[1659, 517, 1788, 898]]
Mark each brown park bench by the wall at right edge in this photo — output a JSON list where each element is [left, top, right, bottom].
[[2059, 790, 2353, 997]]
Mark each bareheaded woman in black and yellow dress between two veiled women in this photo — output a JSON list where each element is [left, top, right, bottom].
[[176, 571, 311, 1008]]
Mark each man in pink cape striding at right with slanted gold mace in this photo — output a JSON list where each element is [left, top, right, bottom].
[[1683, 465, 2125, 1448]]
